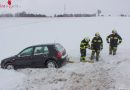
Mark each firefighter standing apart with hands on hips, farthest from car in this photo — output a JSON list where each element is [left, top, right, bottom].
[[106, 30, 122, 55]]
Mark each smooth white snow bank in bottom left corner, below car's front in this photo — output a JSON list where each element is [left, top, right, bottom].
[[0, 69, 25, 90]]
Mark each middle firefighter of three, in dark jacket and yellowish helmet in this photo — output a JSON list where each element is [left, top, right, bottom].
[[91, 32, 103, 62]]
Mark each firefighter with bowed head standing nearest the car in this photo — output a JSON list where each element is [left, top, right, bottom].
[[80, 37, 90, 62]]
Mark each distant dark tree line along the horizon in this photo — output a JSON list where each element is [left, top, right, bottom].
[[0, 10, 130, 17]]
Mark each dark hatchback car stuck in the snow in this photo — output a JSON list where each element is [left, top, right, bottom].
[[1, 43, 69, 69]]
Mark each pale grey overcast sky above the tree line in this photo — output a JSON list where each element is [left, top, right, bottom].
[[0, 0, 130, 15]]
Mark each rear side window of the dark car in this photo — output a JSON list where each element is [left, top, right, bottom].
[[34, 46, 49, 55]]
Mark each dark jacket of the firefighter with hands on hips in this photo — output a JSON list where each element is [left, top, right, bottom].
[[106, 33, 122, 47]]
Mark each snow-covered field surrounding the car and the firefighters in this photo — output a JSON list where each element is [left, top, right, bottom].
[[0, 17, 130, 90]]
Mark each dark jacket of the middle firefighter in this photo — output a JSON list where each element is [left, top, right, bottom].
[[91, 36, 103, 50]]
